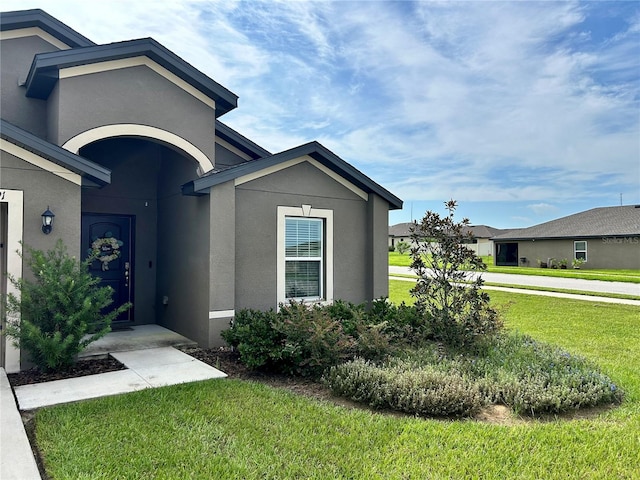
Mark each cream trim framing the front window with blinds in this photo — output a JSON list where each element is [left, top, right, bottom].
[[276, 205, 333, 306]]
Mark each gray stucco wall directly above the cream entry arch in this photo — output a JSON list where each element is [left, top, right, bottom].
[[50, 66, 215, 161]]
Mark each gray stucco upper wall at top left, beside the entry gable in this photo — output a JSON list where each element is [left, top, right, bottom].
[[0, 36, 58, 138]]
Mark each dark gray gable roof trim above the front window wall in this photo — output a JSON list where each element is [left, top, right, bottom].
[[182, 142, 402, 210]]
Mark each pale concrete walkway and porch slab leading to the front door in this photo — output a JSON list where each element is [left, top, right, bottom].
[[0, 325, 227, 480]]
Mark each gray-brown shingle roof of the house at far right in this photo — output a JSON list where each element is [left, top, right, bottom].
[[494, 205, 640, 240]]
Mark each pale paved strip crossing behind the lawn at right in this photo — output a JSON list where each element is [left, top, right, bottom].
[[389, 266, 640, 296]]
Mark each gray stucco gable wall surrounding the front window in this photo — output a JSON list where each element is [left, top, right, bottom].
[[235, 162, 372, 309]]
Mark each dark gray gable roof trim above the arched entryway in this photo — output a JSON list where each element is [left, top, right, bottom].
[[26, 38, 238, 117]]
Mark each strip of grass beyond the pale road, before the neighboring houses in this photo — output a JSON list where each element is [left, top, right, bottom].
[[389, 252, 640, 283]]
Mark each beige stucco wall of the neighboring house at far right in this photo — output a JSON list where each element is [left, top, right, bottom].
[[518, 236, 640, 269]]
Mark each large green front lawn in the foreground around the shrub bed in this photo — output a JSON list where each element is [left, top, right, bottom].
[[36, 281, 640, 479]]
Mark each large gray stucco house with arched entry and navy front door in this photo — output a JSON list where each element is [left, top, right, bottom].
[[0, 10, 402, 371]]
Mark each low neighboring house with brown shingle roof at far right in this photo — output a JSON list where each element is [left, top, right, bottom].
[[493, 205, 640, 269]]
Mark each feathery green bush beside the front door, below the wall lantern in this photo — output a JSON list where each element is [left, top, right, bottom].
[[5, 240, 131, 371]]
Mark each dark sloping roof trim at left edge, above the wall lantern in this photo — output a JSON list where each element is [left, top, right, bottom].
[[0, 119, 111, 186]]
